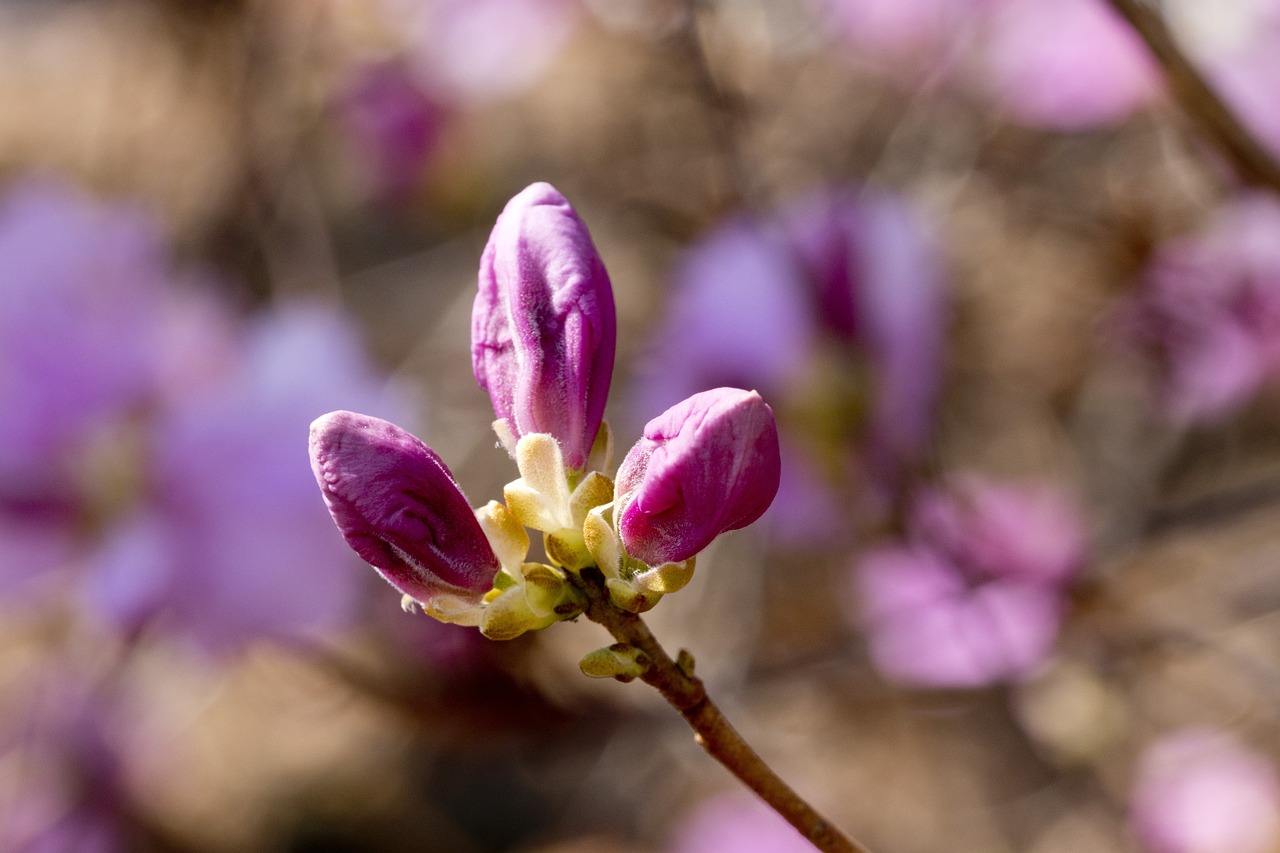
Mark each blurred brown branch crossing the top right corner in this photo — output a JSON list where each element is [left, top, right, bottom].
[[1108, 0, 1280, 193]]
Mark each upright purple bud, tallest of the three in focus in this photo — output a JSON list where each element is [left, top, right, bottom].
[[471, 183, 617, 469]]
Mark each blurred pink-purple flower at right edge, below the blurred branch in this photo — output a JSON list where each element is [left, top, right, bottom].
[[1123, 193, 1280, 421]]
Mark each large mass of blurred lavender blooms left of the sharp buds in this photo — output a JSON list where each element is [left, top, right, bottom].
[[0, 172, 399, 651]]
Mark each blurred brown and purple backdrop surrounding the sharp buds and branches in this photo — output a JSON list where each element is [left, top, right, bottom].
[[0, 0, 1280, 853]]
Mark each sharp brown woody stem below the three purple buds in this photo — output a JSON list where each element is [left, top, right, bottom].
[[579, 569, 870, 853]]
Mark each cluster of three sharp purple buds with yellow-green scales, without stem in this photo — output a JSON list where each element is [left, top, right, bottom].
[[311, 183, 781, 639]]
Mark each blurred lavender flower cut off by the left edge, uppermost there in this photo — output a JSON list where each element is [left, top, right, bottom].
[[0, 179, 170, 505]]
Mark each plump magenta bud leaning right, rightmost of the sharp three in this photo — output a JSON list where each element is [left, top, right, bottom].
[[614, 388, 782, 566]]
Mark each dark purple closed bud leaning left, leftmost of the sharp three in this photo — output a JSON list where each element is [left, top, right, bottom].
[[311, 411, 499, 605]]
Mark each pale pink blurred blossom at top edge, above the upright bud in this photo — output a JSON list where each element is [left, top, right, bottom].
[[385, 0, 581, 102]]
